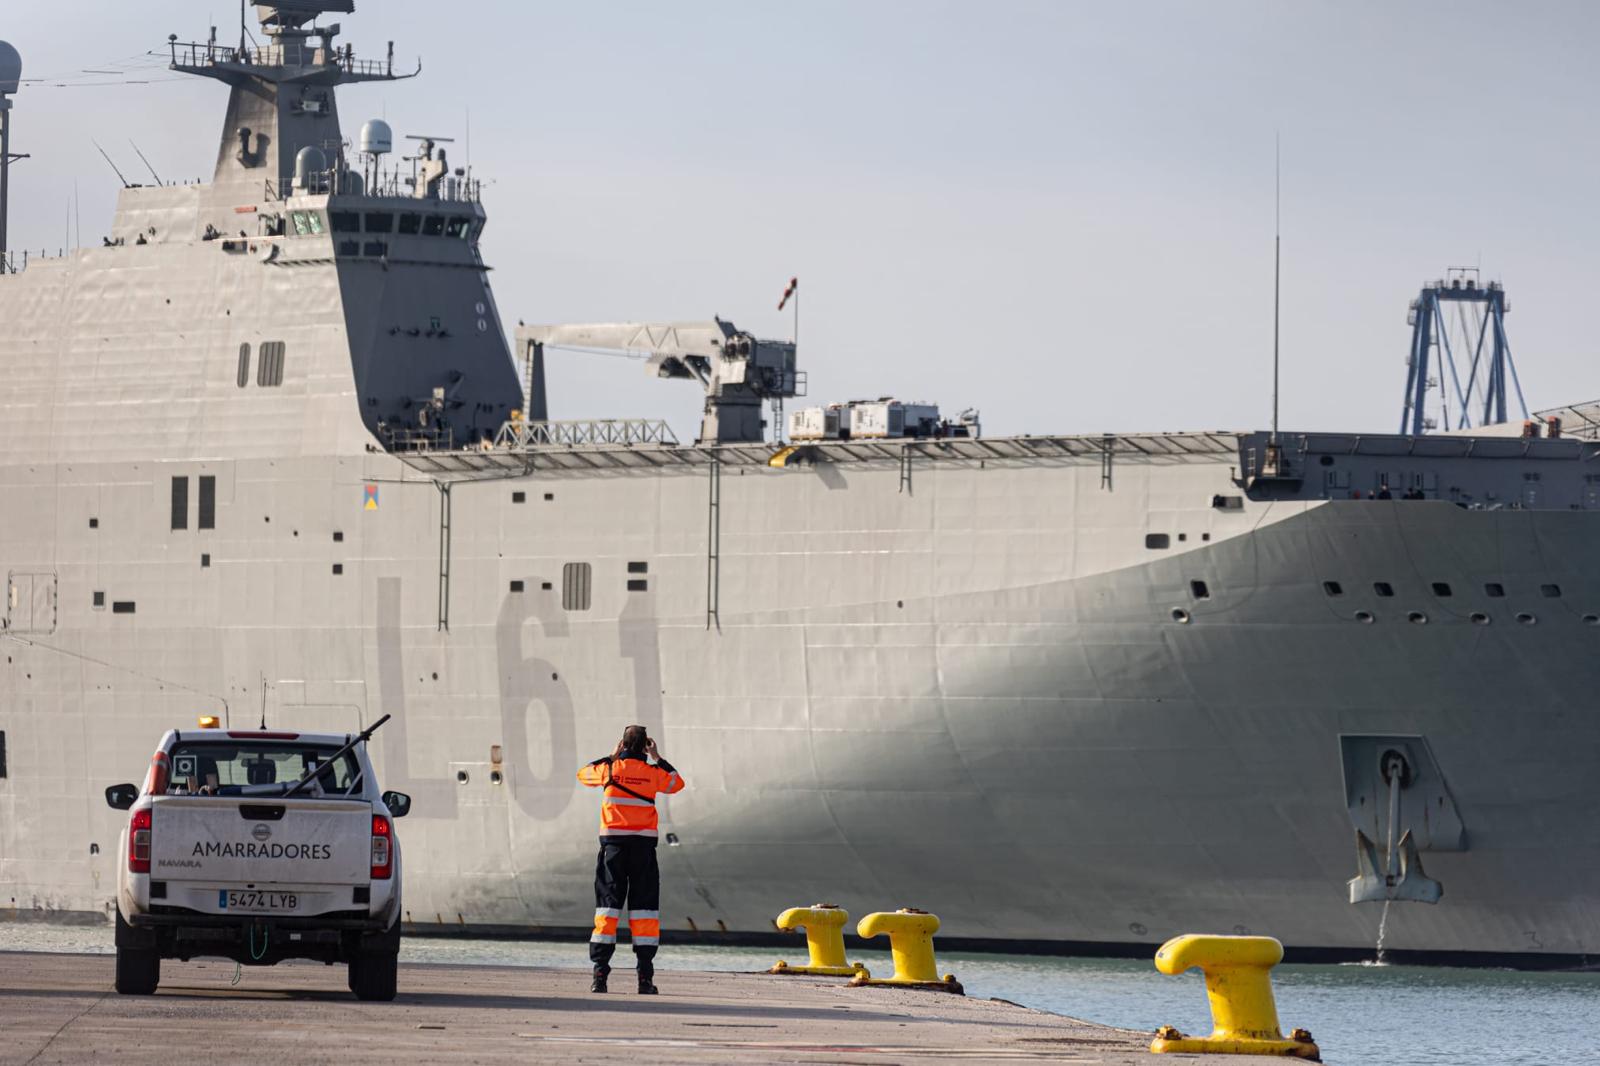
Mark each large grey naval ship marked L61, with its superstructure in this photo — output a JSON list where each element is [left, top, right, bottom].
[[0, 0, 1600, 965]]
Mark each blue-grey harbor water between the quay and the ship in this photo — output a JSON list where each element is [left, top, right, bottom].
[[0, 924, 1600, 1066]]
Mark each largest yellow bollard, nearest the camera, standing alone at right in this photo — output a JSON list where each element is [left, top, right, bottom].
[[1150, 935, 1322, 1063]]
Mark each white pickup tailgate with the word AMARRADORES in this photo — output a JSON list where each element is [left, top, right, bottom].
[[150, 795, 373, 885]]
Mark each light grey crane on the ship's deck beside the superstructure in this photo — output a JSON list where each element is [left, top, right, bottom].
[[517, 317, 805, 443]]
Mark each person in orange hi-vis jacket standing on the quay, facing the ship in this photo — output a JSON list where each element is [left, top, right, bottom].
[[578, 725, 683, 996]]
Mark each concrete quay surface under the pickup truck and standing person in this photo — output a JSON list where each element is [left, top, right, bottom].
[[0, 952, 1280, 1066]]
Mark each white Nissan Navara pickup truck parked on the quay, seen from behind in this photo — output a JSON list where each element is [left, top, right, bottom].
[[106, 715, 411, 1000]]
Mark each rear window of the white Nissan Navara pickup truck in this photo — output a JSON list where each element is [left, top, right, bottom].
[[166, 741, 362, 797]]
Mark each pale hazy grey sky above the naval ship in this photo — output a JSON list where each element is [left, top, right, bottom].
[[0, 0, 1600, 434]]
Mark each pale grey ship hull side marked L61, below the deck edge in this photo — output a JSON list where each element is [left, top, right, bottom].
[[0, 444, 1600, 962]]
